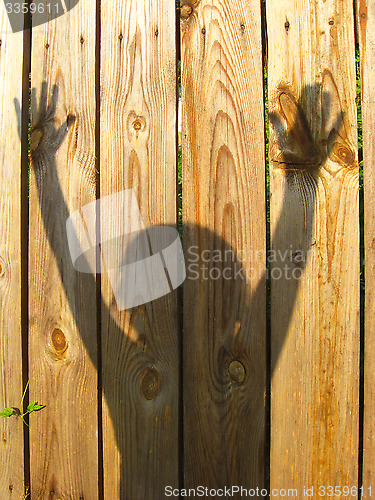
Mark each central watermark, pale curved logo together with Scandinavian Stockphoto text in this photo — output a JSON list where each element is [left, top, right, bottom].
[[66, 189, 308, 310]]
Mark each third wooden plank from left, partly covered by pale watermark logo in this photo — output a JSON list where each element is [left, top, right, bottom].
[[100, 0, 179, 499]]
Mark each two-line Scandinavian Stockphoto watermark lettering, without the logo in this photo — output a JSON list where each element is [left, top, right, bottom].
[[185, 246, 309, 281]]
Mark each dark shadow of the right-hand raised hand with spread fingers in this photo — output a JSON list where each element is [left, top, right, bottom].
[[269, 70, 356, 180]]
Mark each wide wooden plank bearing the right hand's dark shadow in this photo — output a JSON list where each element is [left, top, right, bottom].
[[267, 0, 359, 492]]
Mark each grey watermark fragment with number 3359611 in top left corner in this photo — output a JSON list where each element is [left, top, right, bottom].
[[3, 0, 79, 33]]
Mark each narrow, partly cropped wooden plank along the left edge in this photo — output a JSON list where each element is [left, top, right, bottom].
[[0, 3, 24, 499]]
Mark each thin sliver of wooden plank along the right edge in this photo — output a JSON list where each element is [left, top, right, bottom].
[[356, 0, 375, 499]]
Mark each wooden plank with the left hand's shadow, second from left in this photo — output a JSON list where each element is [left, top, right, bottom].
[[29, 0, 98, 499]]
